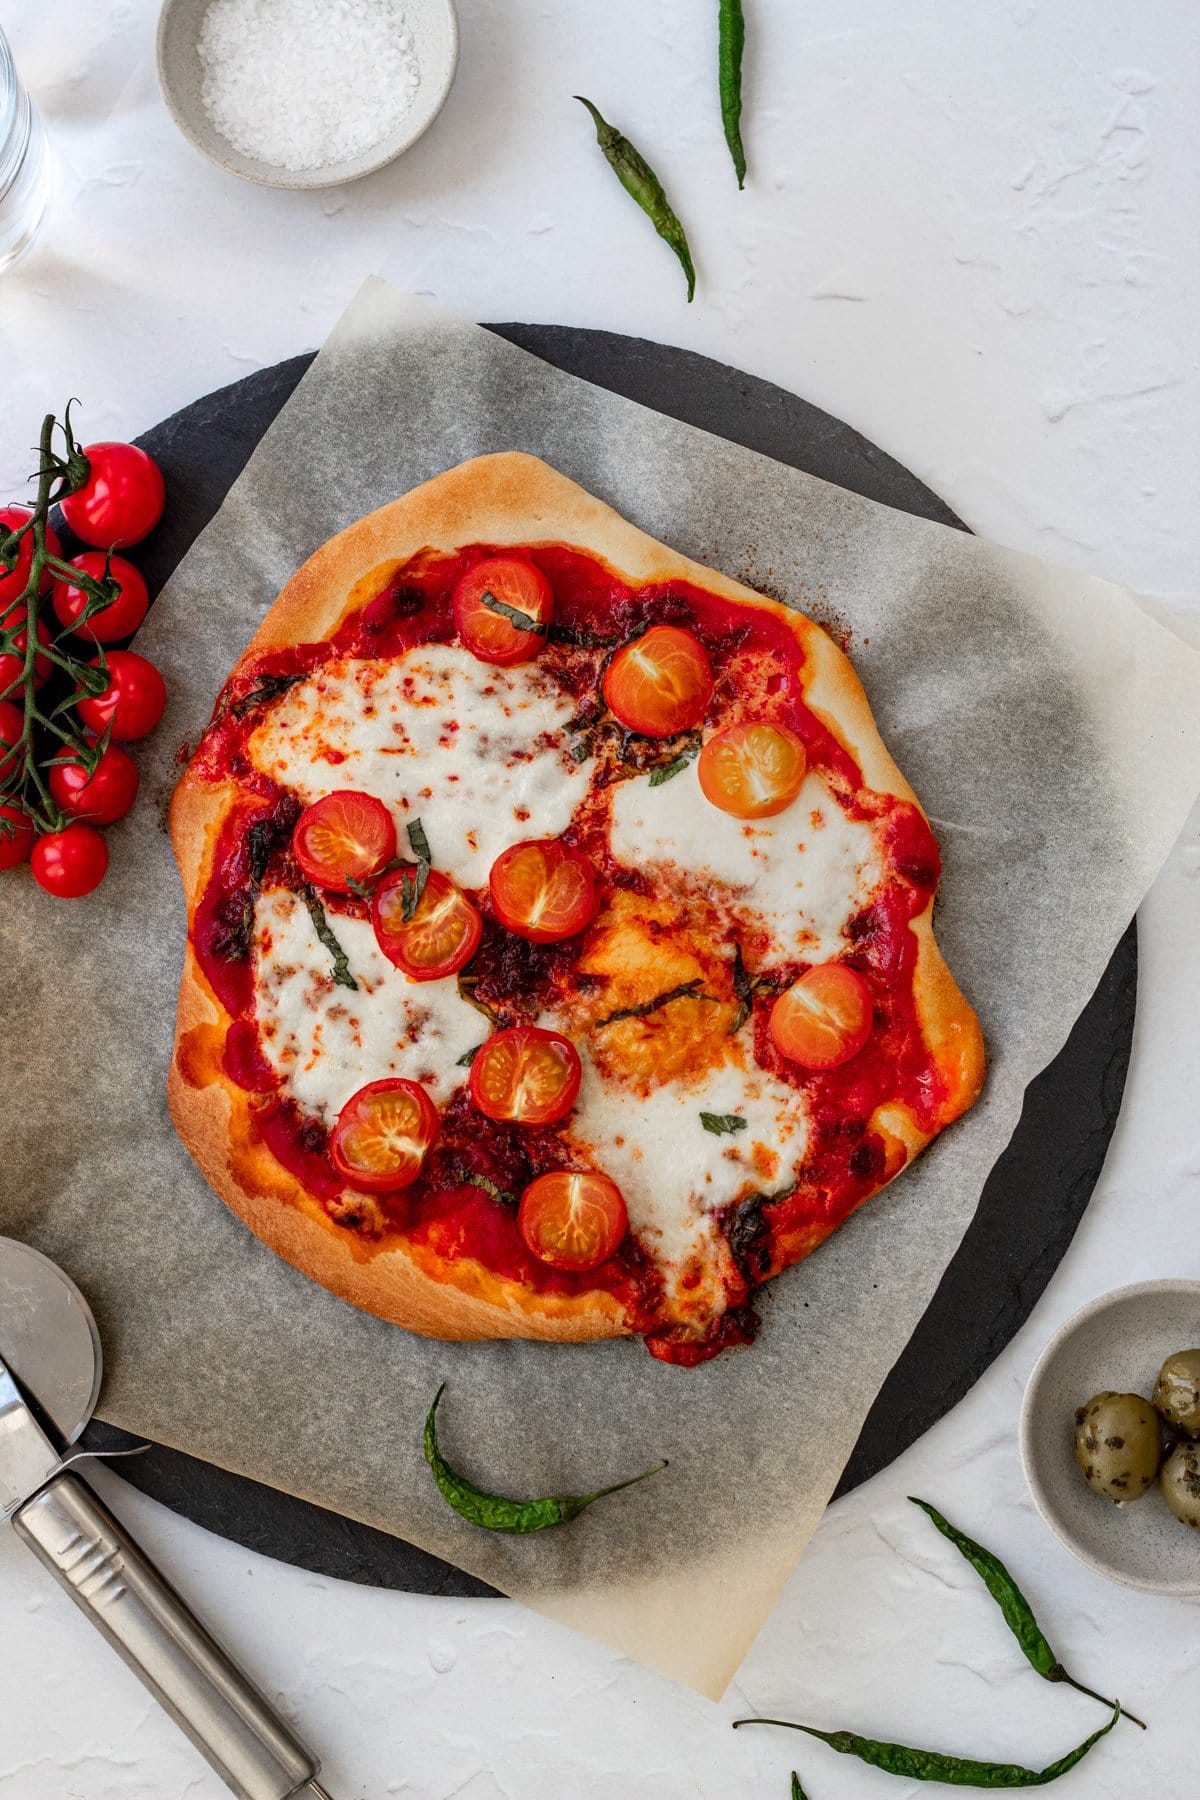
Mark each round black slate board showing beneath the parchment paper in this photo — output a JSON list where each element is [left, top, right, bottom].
[[85, 324, 1137, 1595]]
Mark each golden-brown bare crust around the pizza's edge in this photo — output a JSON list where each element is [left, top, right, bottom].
[[167, 452, 984, 1343]]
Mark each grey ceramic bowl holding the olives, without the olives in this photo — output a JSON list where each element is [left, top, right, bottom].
[[1020, 1282, 1200, 1595]]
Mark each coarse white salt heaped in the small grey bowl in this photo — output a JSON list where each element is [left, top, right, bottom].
[[196, 0, 421, 173]]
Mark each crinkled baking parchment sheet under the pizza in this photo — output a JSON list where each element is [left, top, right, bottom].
[[0, 281, 1200, 1696]]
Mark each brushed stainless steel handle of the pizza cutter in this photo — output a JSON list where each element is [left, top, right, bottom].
[[13, 1474, 320, 1800]]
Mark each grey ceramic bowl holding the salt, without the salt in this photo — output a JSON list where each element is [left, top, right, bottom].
[[158, 0, 459, 187]]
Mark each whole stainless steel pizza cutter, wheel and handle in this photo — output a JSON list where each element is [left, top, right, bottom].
[[0, 1237, 329, 1800]]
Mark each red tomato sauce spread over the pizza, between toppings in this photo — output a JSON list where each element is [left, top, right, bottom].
[[193, 544, 945, 1364]]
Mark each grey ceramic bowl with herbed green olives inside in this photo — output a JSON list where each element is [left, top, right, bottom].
[[1020, 1280, 1200, 1595]]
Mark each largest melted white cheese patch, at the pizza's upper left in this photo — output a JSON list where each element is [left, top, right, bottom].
[[248, 644, 592, 887]]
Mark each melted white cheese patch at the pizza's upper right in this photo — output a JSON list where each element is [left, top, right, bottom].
[[610, 763, 883, 961]]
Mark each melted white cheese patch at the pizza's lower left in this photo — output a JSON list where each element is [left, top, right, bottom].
[[254, 889, 488, 1125]]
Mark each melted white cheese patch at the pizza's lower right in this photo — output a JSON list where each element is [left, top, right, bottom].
[[570, 1051, 808, 1291]]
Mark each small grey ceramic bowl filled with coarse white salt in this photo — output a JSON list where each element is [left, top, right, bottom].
[[158, 0, 459, 187]]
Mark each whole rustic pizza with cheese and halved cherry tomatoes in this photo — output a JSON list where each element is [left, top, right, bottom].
[[169, 454, 984, 1366]]
